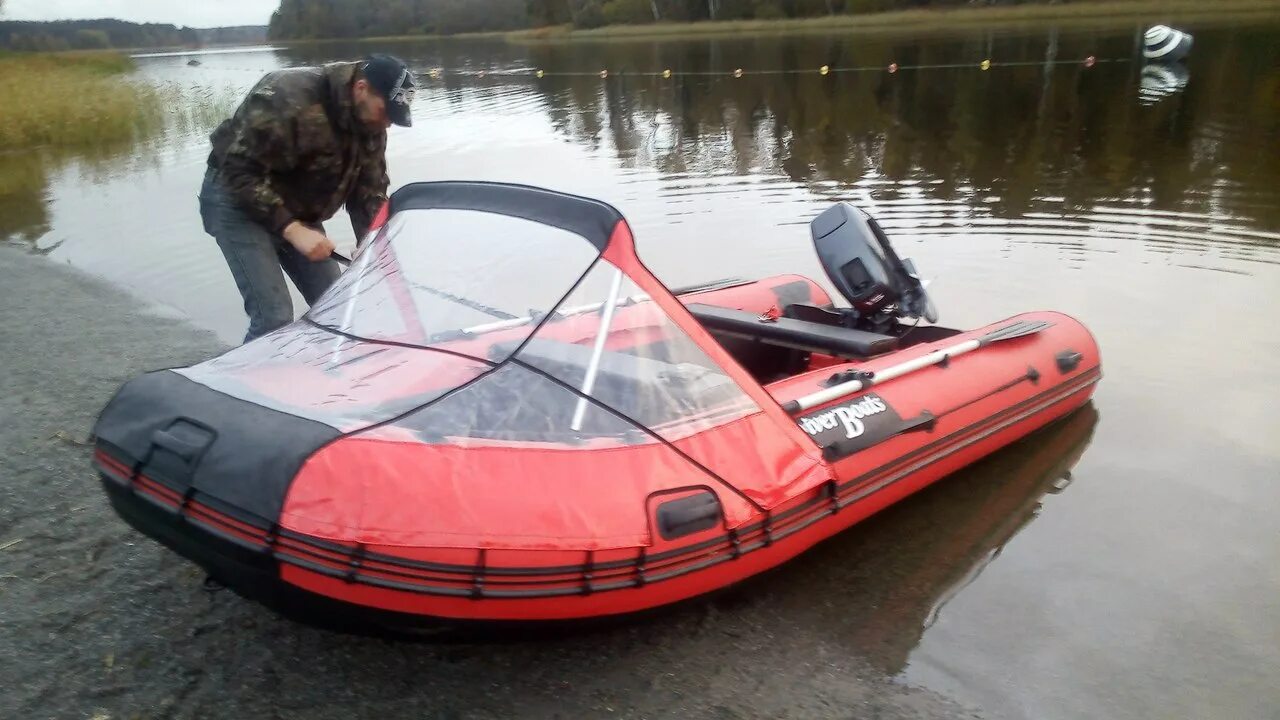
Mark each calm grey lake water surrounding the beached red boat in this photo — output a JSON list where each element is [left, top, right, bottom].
[[0, 16, 1280, 719]]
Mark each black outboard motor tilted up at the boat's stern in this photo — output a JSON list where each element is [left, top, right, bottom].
[[809, 202, 938, 333]]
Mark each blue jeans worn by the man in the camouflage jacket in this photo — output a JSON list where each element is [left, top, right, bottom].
[[200, 168, 340, 342]]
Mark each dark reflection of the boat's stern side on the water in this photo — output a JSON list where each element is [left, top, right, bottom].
[[747, 404, 1100, 675]]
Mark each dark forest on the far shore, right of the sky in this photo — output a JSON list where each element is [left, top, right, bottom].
[[269, 0, 1070, 40]]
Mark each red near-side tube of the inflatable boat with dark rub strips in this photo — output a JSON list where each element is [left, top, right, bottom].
[[99, 299, 1101, 628]]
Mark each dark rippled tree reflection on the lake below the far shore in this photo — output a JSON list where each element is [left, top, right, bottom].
[[264, 27, 1280, 283]]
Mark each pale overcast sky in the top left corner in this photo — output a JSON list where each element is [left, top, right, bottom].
[[0, 0, 280, 27]]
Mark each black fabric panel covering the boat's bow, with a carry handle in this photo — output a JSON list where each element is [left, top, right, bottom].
[[93, 370, 340, 521]]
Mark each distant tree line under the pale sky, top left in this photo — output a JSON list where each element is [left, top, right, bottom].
[[0, 19, 266, 51]]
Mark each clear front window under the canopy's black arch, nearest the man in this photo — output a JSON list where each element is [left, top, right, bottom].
[[308, 209, 599, 361]]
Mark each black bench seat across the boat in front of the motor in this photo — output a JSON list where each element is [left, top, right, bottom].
[[686, 302, 897, 357]]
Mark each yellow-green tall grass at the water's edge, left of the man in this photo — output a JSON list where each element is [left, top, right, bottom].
[[0, 54, 165, 150]]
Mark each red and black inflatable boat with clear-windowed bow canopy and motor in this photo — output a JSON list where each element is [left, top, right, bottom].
[[95, 182, 1101, 630]]
